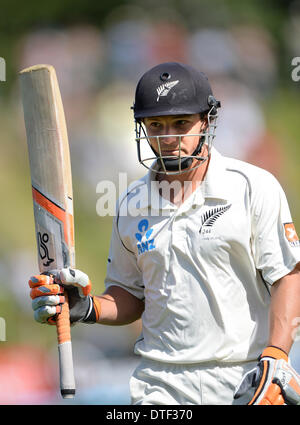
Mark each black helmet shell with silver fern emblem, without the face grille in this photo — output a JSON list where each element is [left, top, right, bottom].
[[133, 62, 220, 120]]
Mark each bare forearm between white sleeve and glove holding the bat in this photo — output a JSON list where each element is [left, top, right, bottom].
[[96, 286, 145, 326]]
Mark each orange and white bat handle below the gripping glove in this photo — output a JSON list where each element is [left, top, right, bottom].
[[56, 290, 75, 398]]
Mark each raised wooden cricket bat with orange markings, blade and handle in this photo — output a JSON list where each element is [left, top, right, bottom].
[[20, 65, 75, 398]]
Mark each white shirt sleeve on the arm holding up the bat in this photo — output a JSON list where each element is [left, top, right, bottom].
[[104, 217, 144, 300]]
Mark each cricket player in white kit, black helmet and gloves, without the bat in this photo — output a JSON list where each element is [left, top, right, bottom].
[[29, 63, 300, 405]]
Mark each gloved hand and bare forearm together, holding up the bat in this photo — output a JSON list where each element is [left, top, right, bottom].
[[29, 269, 144, 326]]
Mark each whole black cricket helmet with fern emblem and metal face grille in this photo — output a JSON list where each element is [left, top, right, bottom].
[[132, 62, 221, 174]]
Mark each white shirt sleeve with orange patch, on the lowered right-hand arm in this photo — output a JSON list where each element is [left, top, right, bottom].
[[252, 172, 300, 285]]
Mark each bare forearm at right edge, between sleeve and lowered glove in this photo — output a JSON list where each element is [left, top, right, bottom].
[[268, 268, 300, 354]]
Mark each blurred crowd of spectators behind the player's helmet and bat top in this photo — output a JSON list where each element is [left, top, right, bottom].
[[18, 8, 290, 188]]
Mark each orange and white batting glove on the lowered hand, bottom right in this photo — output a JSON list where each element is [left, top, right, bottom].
[[234, 346, 300, 405]]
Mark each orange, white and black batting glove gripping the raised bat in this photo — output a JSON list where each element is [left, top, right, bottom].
[[28, 268, 100, 325]]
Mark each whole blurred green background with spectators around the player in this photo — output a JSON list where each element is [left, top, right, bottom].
[[0, 0, 300, 404]]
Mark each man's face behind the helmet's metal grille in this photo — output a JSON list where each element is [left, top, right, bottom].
[[144, 114, 207, 156]]
